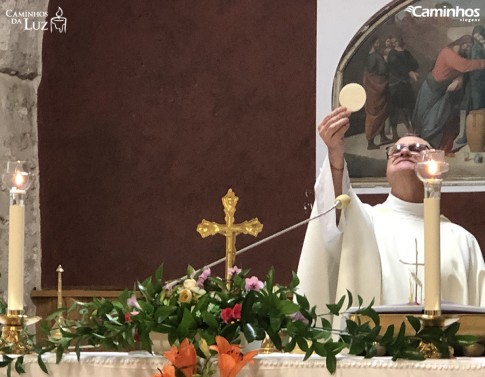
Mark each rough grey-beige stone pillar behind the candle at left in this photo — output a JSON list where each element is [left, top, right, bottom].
[[0, 0, 48, 315]]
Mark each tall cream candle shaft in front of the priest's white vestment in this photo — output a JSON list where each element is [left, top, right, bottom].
[[424, 197, 441, 315]]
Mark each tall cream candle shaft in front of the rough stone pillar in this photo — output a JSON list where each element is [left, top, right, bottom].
[[7, 191, 25, 310]]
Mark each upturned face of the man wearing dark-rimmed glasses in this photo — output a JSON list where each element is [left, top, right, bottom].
[[386, 136, 430, 187]]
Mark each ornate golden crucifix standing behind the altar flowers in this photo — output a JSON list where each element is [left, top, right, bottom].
[[197, 189, 263, 284]]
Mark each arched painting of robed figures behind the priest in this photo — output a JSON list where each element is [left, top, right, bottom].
[[332, 0, 485, 187]]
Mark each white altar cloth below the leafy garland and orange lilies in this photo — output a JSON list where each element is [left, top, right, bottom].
[[0, 352, 485, 377]]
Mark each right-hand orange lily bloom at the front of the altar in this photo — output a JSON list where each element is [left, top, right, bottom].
[[210, 336, 258, 377]]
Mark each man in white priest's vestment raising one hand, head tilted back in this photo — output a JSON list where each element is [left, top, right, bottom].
[[298, 108, 485, 314]]
